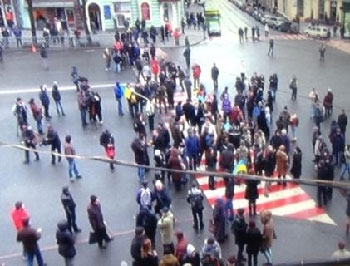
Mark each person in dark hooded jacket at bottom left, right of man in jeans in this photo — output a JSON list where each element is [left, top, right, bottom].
[[56, 220, 77, 266]]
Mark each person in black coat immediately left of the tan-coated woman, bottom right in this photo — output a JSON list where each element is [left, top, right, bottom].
[[245, 220, 262, 266]]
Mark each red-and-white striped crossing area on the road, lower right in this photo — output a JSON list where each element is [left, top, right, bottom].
[[196, 157, 336, 225]]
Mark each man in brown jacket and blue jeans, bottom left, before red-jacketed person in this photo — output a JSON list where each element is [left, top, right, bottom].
[[17, 218, 47, 266]]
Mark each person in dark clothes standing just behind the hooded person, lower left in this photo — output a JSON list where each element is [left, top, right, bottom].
[[61, 186, 81, 233]]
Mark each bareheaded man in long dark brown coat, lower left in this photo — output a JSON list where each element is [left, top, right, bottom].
[[87, 195, 112, 249]]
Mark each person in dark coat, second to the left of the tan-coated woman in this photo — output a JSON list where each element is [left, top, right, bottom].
[[232, 209, 248, 262]]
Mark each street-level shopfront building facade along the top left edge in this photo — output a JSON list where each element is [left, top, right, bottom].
[[14, 0, 184, 31]]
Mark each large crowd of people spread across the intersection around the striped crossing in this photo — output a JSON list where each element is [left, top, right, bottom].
[[8, 11, 350, 266]]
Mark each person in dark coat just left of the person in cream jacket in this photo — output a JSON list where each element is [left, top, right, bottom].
[[136, 208, 158, 247]]
